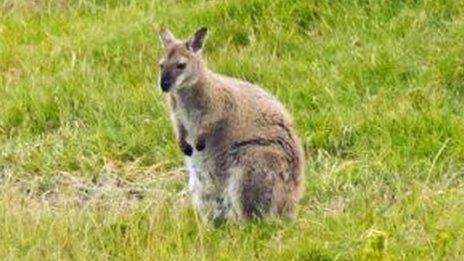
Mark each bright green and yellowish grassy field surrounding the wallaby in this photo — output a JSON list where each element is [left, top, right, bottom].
[[0, 0, 464, 260]]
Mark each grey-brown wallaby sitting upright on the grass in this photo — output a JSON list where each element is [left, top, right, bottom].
[[159, 27, 303, 221]]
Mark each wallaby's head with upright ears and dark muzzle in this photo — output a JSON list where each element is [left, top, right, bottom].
[[159, 27, 208, 92]]
